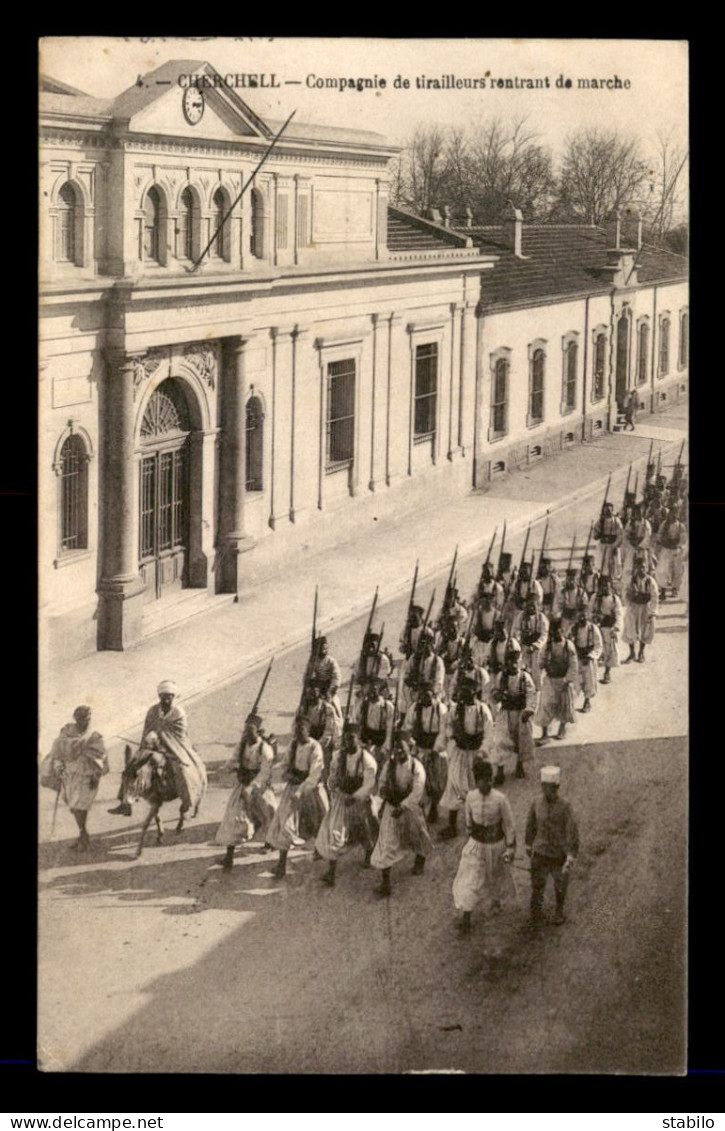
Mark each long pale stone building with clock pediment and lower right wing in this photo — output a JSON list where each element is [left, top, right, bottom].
[[40, 61, 688, 659]]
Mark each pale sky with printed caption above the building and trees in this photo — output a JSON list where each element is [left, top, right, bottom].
[[41, 36, 688, 161]]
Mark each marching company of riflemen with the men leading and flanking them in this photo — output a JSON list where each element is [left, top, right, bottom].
[[44, 458, 688, 933]]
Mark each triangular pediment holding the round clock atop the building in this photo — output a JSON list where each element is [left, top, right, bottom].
[[113, 60, 273, 141]]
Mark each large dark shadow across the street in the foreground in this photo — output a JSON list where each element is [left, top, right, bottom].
[[41, 739, 687, 1073]]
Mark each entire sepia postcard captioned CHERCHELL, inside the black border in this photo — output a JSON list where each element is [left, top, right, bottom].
[[37, 36, 690, 1078]]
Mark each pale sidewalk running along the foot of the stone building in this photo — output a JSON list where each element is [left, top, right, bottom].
[[40, 406, 687, 753]]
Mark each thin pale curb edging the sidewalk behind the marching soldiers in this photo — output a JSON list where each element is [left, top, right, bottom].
[[101, 439, 681, 744]]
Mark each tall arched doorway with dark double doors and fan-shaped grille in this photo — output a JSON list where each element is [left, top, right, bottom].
[[138, 379, 191, 601]]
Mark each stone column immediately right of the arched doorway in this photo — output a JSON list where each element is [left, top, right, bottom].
[[219, 337, 254, 596]]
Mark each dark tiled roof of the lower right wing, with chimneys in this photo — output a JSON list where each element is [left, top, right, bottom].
[[458, 224, 688, 304]]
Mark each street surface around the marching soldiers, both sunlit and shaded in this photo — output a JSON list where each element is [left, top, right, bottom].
[[38, 408, 688, 1073]]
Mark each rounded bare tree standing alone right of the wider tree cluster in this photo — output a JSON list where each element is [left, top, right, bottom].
[[554, 127, 648, 224]]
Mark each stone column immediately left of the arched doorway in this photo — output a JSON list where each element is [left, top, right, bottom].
[[97, 351, 145, 651]]
